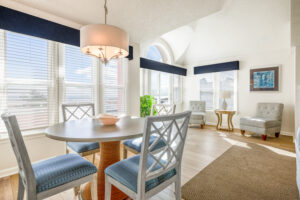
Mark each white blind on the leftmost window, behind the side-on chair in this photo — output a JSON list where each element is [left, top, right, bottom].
[[0, 30, 54, 132]]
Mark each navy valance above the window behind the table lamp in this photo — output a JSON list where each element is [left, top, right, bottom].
[[194, 61, 240, 74]]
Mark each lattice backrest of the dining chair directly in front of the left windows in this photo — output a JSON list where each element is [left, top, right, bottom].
[[62, 103, 95, 122]]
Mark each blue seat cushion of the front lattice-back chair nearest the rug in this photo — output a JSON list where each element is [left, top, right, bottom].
[[105, 155, 176, 192]]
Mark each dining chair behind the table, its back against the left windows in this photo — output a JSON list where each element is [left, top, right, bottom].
[[62, 103, 100, 163]]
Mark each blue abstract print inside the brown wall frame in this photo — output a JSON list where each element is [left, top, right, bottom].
[[253, 70, 275, 88]]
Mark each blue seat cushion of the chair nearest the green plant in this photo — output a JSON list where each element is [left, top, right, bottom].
[[123, 135, 166, 153]]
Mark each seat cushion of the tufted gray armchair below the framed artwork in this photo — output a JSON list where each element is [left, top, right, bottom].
[[240, 117, 281, 128]]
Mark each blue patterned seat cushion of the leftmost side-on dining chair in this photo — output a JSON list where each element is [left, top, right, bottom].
[[32, 154, 97, 193]]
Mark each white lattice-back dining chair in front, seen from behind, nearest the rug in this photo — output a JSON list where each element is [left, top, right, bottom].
[[105, 111, 191, 200]]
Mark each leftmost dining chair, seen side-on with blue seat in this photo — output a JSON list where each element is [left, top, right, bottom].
[[1, 114, 97, 200]]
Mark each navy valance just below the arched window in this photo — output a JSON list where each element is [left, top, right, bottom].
[[140, 58, 186, 76]]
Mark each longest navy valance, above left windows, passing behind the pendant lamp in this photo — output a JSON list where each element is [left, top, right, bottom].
[[0, 6, 133, 60]]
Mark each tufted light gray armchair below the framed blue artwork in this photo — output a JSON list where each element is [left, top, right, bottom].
[[240, 103, 283, 140]]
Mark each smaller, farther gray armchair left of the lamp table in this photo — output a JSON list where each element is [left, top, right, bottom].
[[190, 101, 206, 128]]
